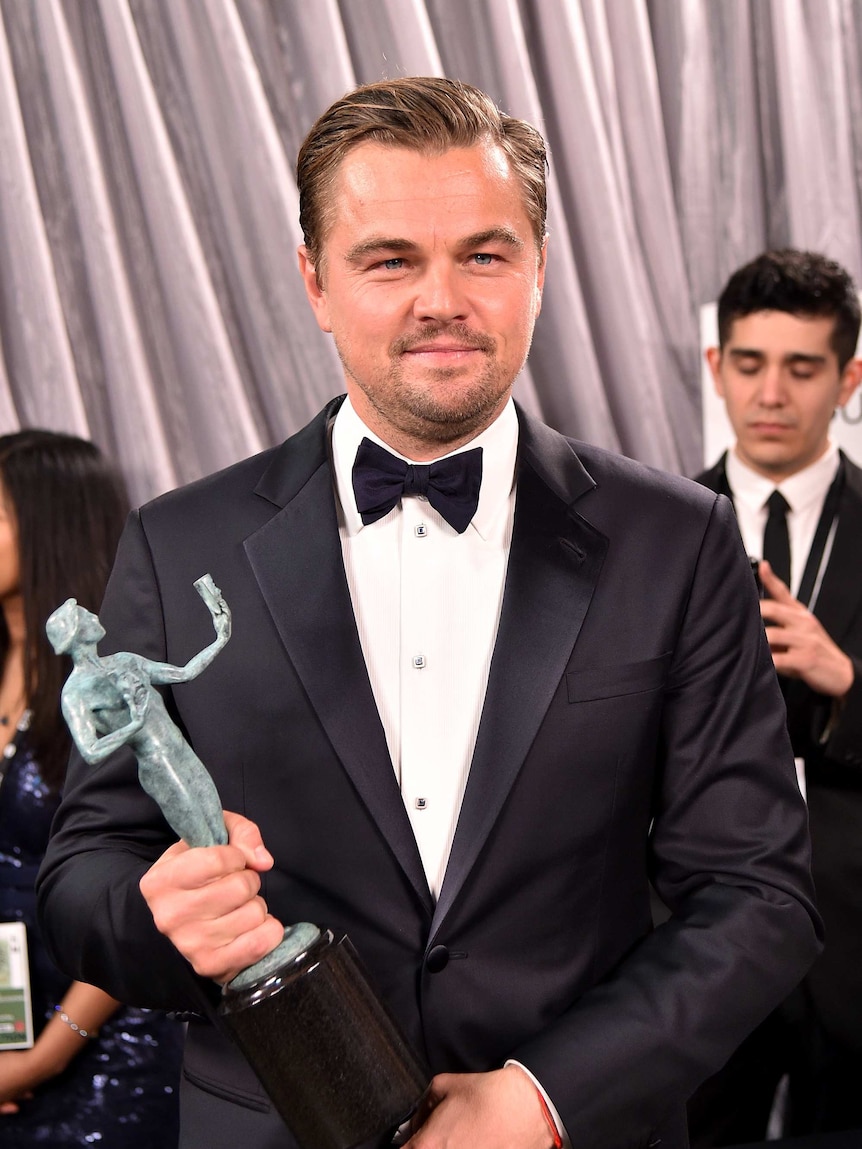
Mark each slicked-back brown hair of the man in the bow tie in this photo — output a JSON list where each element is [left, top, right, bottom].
[[297, 76, 547, 277]]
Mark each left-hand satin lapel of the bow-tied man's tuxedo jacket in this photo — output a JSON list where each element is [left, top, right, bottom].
[[245, 406, 430, 907]]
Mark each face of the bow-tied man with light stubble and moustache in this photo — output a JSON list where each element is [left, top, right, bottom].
[[299, 144, 545, 460]]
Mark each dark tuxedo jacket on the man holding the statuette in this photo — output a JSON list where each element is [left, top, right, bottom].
[[40, 401, 819, 1149]]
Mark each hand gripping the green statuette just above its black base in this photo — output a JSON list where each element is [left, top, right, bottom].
[[140, 810, 284, 984]]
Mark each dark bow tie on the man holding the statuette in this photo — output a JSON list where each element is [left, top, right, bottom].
[[353, 439, 482, 534]]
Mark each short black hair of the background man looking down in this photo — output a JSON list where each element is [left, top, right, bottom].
[[718, 247, 860, 371]]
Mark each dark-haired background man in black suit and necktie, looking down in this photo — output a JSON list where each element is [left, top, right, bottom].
[[691, 250, 862, 1146]]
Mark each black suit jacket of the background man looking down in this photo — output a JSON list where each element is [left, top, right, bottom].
[[698, 454, 862, 1055]]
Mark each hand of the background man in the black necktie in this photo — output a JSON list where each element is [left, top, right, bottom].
[[759, 562, 854, 699]]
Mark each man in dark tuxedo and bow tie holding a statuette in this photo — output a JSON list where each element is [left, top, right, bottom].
[[40, 78, 819, 1149]]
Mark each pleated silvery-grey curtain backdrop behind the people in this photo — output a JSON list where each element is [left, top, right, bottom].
[[0, 0, 862, 501]]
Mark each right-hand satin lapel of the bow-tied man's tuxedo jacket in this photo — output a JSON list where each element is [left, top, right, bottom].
[[432, 411, 608, 935]]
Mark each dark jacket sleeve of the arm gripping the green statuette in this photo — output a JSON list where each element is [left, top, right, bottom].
[[37, 512, 220, 1012]]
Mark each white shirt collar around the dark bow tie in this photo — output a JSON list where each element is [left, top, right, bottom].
[[332, 398, 518, 539]]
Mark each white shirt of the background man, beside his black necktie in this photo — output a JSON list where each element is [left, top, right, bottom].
[[726, 442, 840, 607]]
